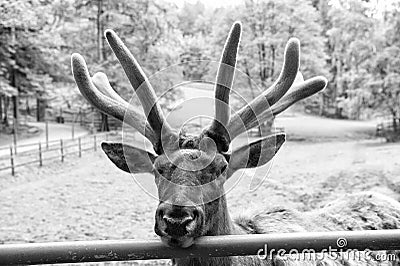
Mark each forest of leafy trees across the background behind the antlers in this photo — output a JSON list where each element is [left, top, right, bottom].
[[0, 0, 400, 136]]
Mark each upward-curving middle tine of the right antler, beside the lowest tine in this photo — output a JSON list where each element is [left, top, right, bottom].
[[228, 38, 300, 139]]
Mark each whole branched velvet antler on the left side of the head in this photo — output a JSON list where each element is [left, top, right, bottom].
[[72, 30, 174, 154]]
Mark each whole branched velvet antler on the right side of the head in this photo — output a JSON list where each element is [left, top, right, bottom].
[[204, 25, 327, 152]]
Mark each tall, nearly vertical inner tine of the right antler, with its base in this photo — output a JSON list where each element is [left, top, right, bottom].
[[205, 22, 242, 152]]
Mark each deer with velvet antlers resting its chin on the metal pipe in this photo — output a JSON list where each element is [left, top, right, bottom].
[[71, 22, 400, 265]]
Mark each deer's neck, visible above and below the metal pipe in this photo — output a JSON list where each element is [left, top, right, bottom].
[[172, 196, 235, 266]]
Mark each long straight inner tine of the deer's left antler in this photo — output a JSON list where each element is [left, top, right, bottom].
[[105, 30, 172, 149]]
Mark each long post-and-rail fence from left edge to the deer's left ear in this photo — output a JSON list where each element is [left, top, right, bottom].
[[0, 131, 121, 175]]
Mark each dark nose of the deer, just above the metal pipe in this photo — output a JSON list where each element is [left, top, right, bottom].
[[157, 204, 204, 237]]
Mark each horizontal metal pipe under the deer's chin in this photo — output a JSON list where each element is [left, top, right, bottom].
[[0, 230, 400, 265]]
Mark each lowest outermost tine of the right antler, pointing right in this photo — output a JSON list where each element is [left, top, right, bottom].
[[249, 76, 328, 128]]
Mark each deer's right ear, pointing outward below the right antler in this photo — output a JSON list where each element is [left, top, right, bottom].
[[228, 134, 285, 177]]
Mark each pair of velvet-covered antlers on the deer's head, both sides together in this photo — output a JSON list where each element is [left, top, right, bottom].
[[72, 22, 327, 154]]
